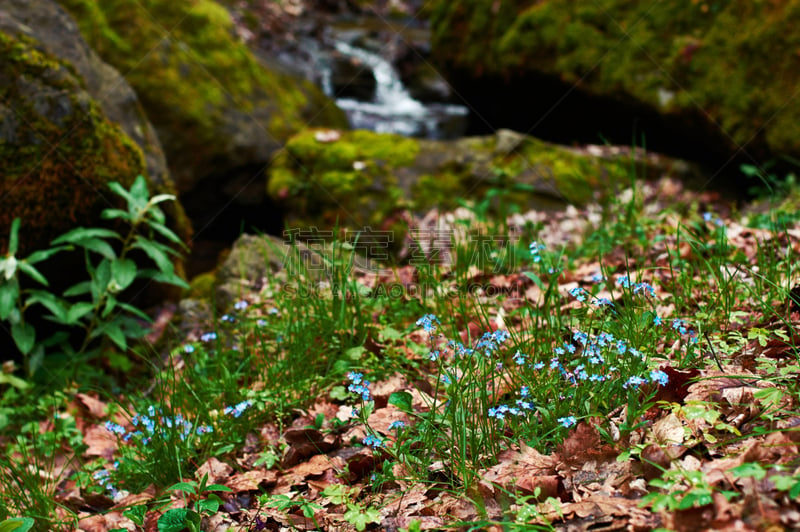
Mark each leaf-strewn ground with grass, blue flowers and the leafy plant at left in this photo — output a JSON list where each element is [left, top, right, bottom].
[[0, 167, 800, 531]]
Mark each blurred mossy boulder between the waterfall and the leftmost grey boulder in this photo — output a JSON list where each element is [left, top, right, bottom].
[[59, 0, 345, 192]]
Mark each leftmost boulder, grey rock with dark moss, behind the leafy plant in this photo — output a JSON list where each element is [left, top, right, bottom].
[[0, 0, 191, 252]]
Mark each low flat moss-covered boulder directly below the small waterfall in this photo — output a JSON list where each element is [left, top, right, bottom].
[[267, 129, 694, 230]]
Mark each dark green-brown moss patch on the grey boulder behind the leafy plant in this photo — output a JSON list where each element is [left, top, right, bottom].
[[0, 32, 146, 256]]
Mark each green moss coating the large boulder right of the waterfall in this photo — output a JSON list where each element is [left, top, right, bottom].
[[431, 0, 800, 161]]
